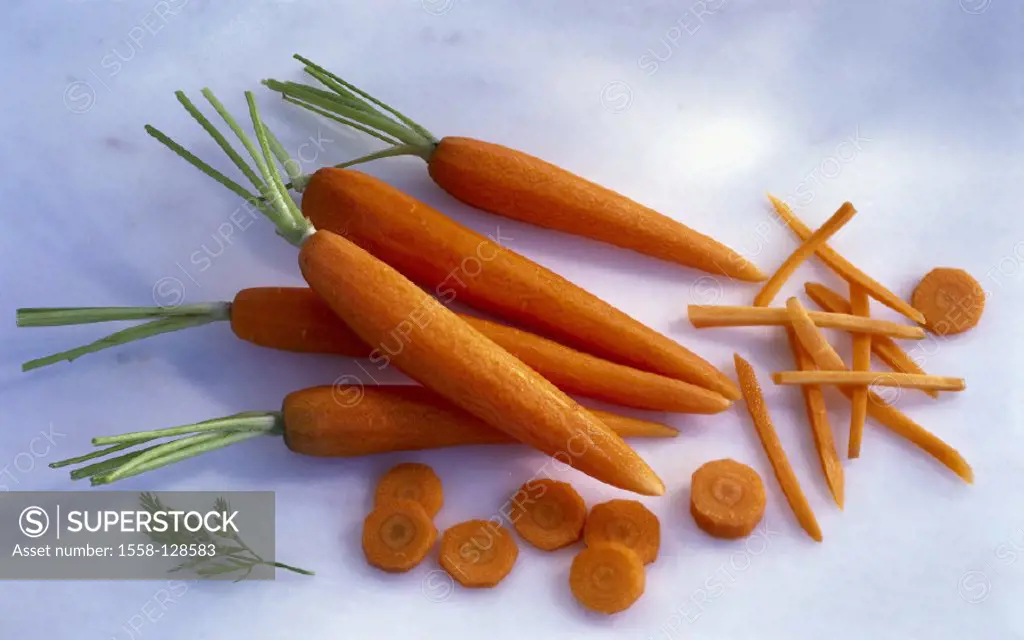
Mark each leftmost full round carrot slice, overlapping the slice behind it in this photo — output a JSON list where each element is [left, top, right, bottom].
[[362, 500, 437, 572]]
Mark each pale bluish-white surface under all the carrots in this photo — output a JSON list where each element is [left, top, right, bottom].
[[0, 0, 1024, 640]]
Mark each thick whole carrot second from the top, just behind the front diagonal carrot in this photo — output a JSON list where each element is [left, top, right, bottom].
[[146, 92, 738, 399]]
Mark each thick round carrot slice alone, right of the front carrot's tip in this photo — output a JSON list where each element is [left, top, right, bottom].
[[690, 458, 767, 539]]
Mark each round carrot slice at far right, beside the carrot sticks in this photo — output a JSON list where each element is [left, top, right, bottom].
[[910, 268, 985, 336]]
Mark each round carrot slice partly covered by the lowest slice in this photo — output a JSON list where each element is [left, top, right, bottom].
[[583, 500, 662, 564]]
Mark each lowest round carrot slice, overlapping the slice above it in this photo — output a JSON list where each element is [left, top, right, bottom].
[[569, 543, 646, 613]]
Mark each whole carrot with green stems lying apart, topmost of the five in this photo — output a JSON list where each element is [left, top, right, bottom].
[[263, 55, 764, 281]]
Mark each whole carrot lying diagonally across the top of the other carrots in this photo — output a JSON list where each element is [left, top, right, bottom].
[[138, 91, 665, 496]]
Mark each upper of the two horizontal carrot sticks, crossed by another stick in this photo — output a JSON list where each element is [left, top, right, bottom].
[[687, 304, 925, 340]]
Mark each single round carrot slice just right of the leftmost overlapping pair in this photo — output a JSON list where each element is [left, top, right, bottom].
[[440, 520, 519, 588]]
